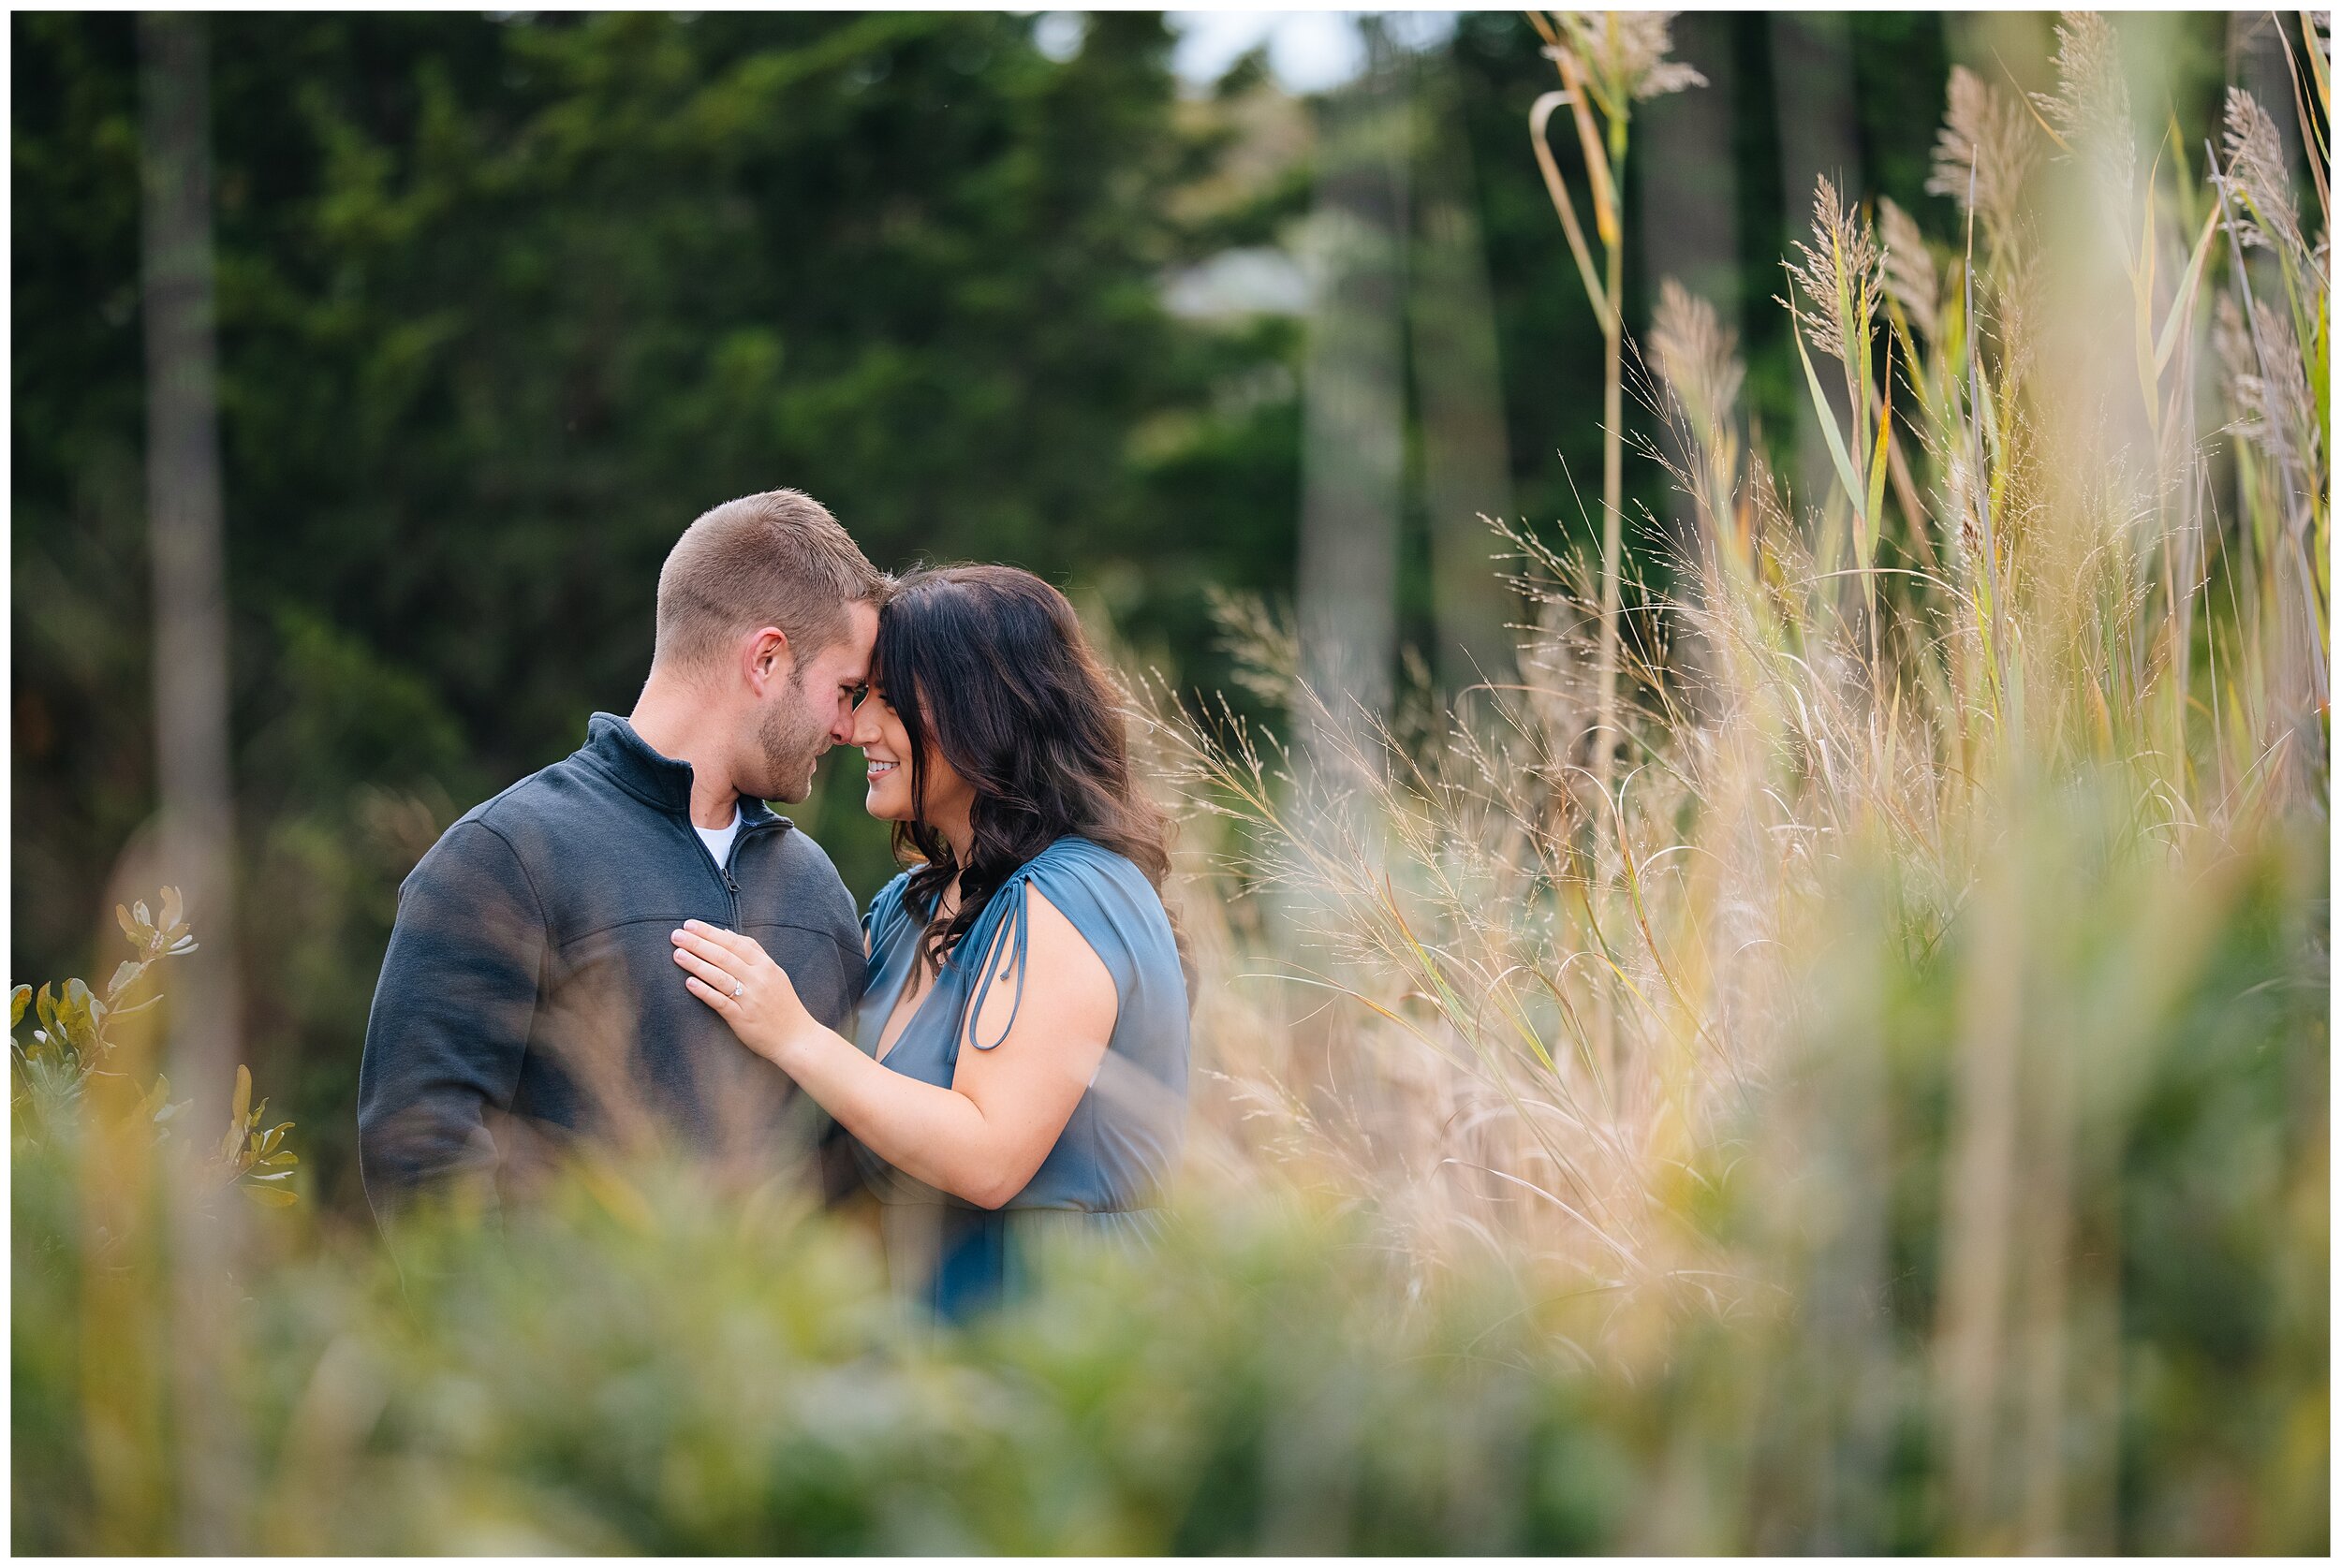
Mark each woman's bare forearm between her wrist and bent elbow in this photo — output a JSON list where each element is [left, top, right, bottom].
[[775, 1028, 1030, 1208]]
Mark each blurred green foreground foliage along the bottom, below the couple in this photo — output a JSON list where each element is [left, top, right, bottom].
[[12, 794, 2330, 1552]]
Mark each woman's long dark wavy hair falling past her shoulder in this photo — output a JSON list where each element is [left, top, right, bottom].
[[871, 566, 1185, 969]]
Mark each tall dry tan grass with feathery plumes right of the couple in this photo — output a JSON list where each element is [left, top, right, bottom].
[[1155, 14, 2330, 1549]]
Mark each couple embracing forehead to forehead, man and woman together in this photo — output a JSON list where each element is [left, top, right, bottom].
[[359, 490, 1187, 1318]]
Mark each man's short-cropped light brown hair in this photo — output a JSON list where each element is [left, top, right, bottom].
[[651, 490, 888, 667]]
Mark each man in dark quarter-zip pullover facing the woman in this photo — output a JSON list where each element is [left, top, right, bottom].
[[359, 490, 885, 1217]]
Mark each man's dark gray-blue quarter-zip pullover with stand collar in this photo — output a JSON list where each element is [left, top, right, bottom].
[[359, 714, 864, 1215]]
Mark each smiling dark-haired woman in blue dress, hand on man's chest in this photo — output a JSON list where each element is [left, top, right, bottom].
[[674, 566, 1187, 1318]]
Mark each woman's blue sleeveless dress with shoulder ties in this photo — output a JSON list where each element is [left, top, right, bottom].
[[852, 838, 1187, 1318]]
